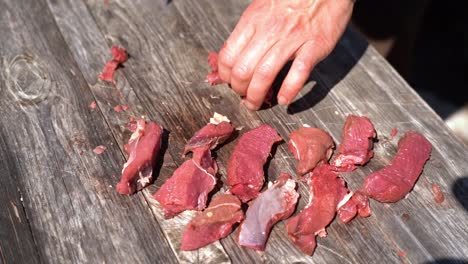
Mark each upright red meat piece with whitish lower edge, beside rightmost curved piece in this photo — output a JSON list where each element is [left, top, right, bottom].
[[332, 115, 376, 171]]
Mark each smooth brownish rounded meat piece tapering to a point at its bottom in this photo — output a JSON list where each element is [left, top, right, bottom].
[[288, 127, 335, 176]]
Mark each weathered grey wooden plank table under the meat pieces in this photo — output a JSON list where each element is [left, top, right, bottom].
[[0, 0, 468, 263]]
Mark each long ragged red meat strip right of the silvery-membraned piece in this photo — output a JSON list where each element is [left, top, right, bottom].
[[286, 164, 348, 255]]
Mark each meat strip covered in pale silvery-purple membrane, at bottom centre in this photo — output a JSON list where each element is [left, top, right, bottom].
[[238, 173, 299, 251]]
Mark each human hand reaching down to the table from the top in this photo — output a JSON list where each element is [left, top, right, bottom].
[[218, 0, 354, 110]]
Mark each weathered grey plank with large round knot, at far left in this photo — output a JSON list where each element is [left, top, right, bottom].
[[0, 1, 175, 263]]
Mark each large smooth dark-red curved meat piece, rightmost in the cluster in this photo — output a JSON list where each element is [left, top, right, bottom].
[[362, 131, 432, 203]]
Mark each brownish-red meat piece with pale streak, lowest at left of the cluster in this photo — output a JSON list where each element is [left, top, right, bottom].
[[180, 194, 244, 250]]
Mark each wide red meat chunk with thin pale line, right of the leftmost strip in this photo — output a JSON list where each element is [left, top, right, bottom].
[[154, 147, 218, 218]]
